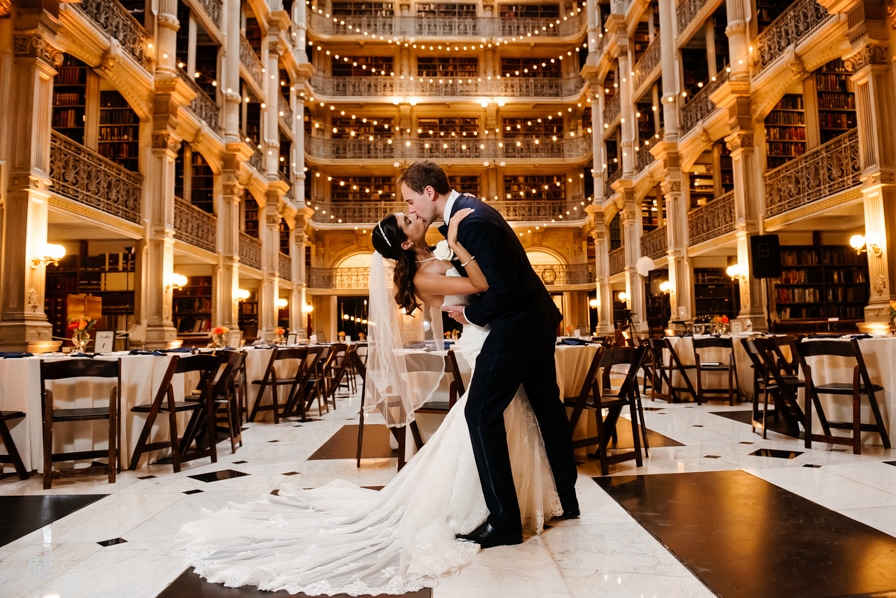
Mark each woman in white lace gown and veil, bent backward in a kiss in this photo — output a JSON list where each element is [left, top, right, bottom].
[[181, 209, 563, 596]]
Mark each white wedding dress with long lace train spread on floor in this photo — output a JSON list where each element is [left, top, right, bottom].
[[182, 270, 563, 596]]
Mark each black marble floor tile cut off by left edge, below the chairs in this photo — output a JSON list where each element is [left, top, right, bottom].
[[0, 494, 108, 546]]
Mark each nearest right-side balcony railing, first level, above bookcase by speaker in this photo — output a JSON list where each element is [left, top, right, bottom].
[[765, 130, 862, 217]]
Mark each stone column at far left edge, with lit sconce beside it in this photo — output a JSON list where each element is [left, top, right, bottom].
[[0, 2, 62, 352]]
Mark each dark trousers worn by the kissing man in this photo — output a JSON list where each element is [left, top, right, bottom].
[[464, 334, 578, 531]]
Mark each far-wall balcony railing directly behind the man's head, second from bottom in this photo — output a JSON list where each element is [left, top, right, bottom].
[[312, 199, 588, 225]]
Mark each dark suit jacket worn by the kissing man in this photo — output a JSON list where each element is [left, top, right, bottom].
[[442, 195, 562, 351]]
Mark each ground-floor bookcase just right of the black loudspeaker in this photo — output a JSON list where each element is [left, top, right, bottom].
[[774, 243, 869, 320]]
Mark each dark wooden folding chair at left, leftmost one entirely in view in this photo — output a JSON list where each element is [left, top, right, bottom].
[[40, 358, 121, 490]]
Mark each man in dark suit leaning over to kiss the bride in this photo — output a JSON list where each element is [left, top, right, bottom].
[[398, 161, 579, 548]]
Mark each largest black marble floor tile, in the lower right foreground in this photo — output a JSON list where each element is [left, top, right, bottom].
[[594, 471, 896, 598]]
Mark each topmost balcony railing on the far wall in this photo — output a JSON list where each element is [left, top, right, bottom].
[[308, 12, 585, 41]]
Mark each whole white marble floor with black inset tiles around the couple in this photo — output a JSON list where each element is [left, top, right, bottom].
[[0, 386, 896, 598]]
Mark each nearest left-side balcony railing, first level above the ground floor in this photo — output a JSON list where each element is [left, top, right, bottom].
[[50, 131, 143, 223]]
